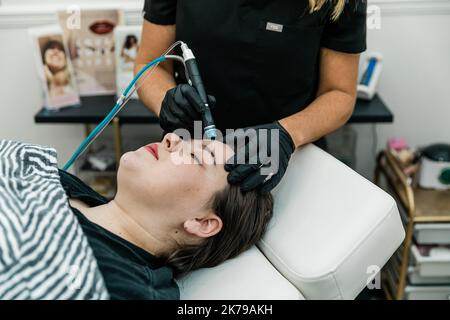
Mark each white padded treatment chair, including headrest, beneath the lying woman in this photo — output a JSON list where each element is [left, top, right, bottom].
[[178, 145, 404, 300]]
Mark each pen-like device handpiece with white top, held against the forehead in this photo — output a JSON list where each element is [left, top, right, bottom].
[[181, 43, 217, 139]]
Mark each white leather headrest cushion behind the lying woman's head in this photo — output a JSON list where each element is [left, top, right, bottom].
[[259, 145, 404, 299]]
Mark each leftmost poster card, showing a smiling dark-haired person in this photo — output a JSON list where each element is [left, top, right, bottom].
[[28, 25, 80, 110]]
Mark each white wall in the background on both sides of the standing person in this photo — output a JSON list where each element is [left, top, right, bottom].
[[0, 0, 450, 177]]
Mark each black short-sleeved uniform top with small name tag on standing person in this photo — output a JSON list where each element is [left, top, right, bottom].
[[144, 0, 367, 130]]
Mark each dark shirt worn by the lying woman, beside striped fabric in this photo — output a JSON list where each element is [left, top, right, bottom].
[[59, 170, 180, 300]]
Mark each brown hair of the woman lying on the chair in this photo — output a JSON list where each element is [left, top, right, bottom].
[[167, 185, 273, 277]]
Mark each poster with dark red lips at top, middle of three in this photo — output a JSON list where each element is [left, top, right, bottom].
[[58, 9, 123, 96]]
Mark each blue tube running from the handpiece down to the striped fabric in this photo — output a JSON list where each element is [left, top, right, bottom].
[[63, 56, 166, 171]]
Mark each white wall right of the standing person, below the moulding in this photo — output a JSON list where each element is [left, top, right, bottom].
[[353, 11, 450, 177]]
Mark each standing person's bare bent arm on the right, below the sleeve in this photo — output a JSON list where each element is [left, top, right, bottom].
[[279, 48, 360, 147]]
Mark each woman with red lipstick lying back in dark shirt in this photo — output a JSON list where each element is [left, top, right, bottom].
[[60, 134, 273, 299]]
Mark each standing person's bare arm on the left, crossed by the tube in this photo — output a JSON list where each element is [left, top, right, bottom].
[[134, 20, 176, 116]]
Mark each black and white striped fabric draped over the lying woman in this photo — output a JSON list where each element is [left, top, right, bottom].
[[0, 140, 108, 299]]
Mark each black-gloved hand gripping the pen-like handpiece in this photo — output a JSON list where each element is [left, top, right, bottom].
[[159, 84, 216, 132]]
